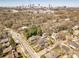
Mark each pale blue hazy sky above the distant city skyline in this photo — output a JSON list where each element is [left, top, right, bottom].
[[0, 0, 79, 7]]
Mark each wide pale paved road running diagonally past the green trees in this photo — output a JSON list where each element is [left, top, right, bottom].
[[6, 28, 40, 58]]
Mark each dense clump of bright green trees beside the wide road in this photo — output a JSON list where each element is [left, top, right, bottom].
[[25, 25, 42, 38]]
